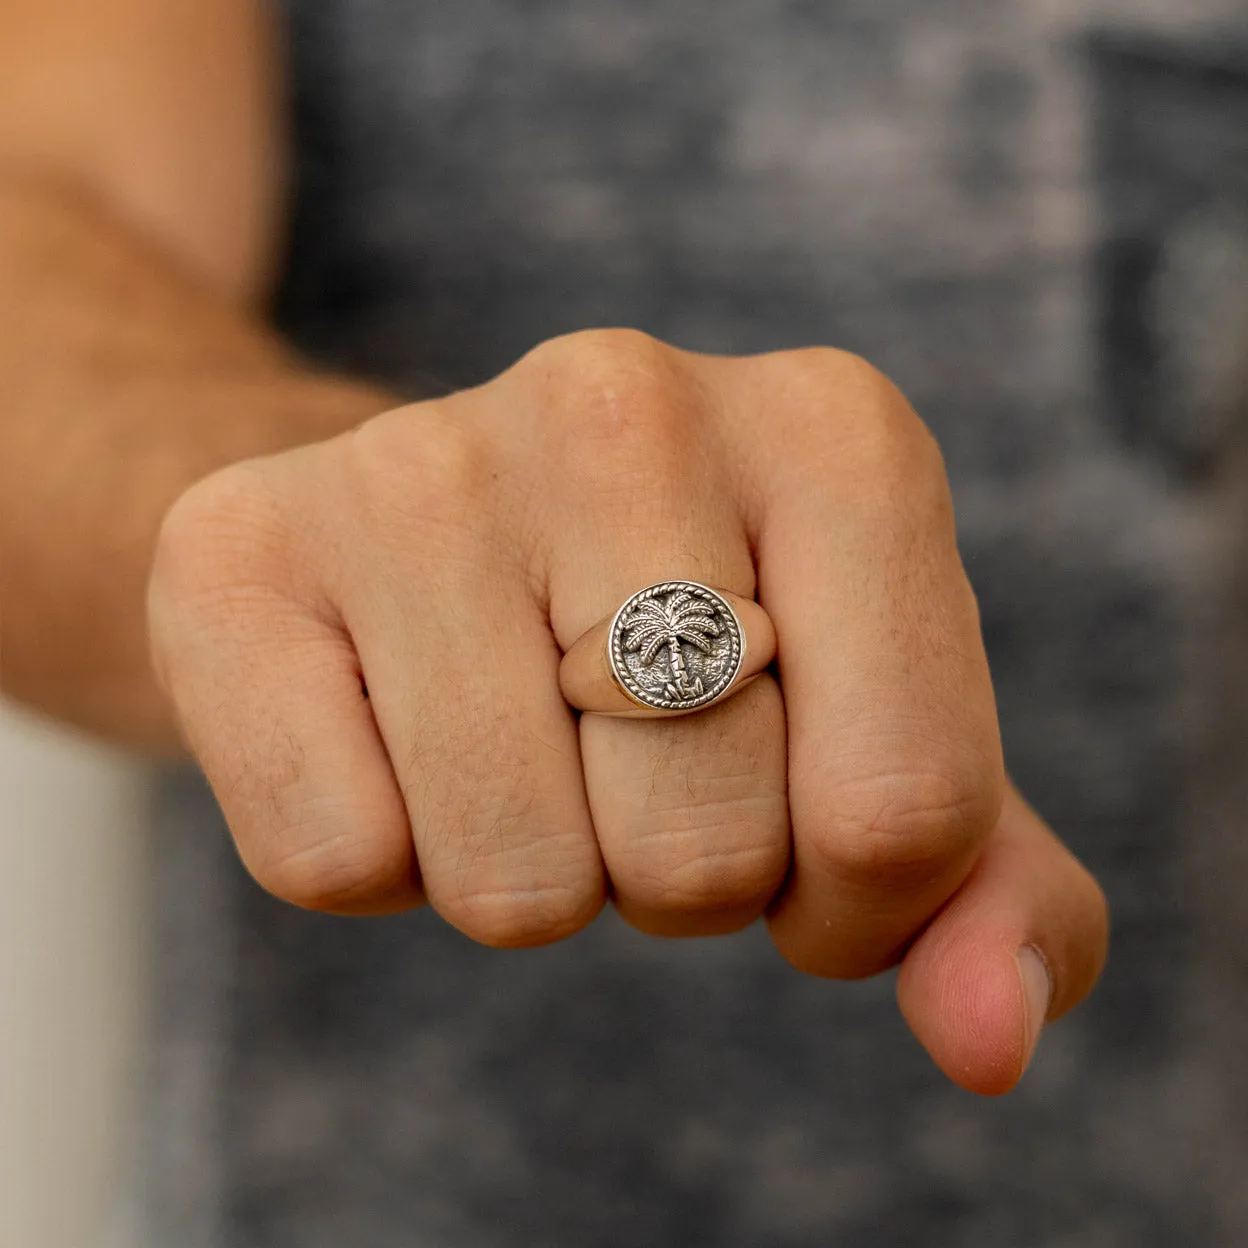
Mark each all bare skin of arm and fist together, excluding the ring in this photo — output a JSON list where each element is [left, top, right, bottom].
[[0, 0, 1107, 1093]]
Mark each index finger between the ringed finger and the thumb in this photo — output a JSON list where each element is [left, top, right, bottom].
[[723, 352, 1005, 978]]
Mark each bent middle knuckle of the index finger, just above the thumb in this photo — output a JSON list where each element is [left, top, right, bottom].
[[802, 764, 1002, 892]]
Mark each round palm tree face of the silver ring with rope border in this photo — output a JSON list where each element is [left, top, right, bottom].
[[607, 580, 745, 711]]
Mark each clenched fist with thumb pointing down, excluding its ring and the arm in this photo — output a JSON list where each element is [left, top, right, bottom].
[[150, 331, 1106, 1092]]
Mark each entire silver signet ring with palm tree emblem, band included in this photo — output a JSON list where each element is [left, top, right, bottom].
[[559, 580, 776, 716]]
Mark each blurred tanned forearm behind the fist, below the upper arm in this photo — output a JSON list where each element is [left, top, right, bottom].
[[0, 177, 394, 749]]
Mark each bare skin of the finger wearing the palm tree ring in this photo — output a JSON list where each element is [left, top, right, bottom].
[[526, 342, 789, 936]]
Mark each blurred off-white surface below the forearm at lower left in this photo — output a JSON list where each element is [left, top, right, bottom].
[[0, 703, 150, 1248]]
